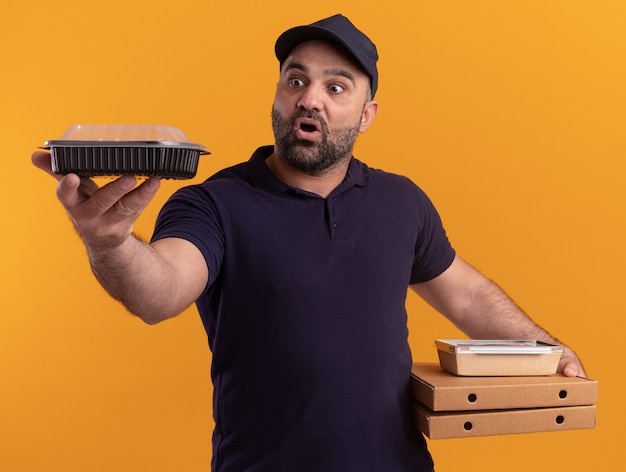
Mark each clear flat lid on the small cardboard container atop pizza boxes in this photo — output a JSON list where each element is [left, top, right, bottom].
[[435, 339, 563, 354]]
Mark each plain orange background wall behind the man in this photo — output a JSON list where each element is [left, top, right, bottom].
[[0, 0, 626, 472]]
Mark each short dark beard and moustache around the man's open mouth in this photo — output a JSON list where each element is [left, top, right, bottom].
[[272, 108, 361, 176]]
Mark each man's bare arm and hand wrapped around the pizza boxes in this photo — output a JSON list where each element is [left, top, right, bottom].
[[411, 256, 585, 377]]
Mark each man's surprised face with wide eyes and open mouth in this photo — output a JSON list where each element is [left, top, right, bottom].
[[272, 41, 376, 175]]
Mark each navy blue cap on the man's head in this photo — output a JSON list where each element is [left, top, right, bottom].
[[274, 15, 378, 97]]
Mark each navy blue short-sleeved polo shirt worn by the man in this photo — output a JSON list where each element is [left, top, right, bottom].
[[153, 146, 454, 472]]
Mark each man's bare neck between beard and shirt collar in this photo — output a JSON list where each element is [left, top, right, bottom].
[[265, 151, 350, 198]]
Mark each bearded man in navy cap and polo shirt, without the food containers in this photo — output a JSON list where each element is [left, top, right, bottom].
[[33, 15, 584, 472]]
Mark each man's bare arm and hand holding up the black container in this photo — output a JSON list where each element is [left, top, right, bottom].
[[32, 152, 208, 324]]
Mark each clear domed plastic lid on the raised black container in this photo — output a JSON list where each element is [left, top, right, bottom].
[[43, 124, 210, 154]]
